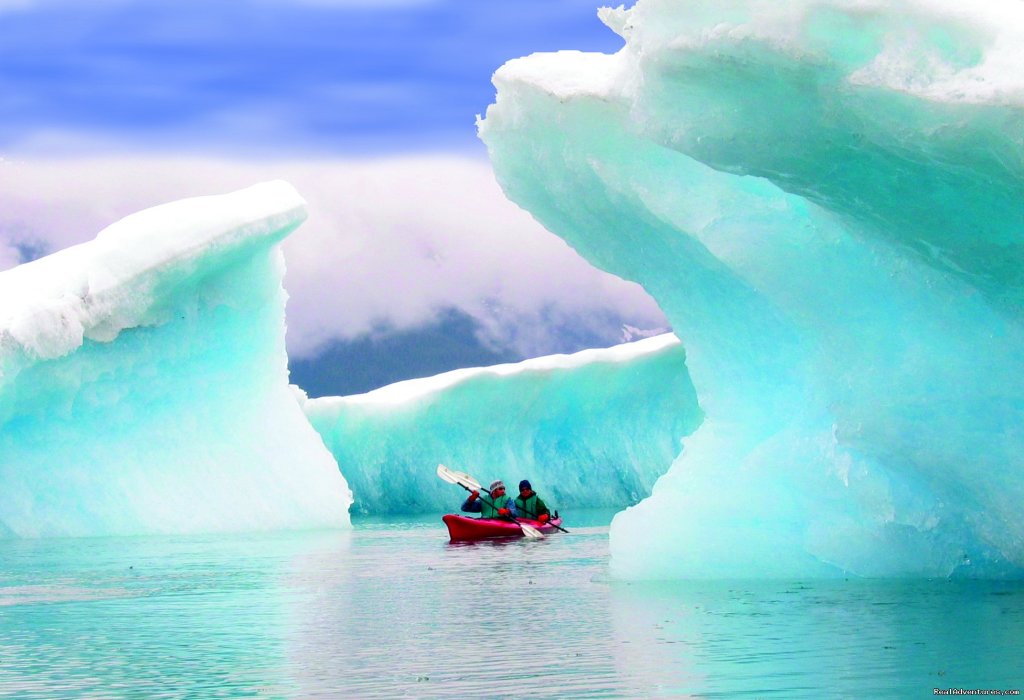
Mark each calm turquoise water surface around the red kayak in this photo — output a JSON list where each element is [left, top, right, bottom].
[[0, 513, 1024, 699]]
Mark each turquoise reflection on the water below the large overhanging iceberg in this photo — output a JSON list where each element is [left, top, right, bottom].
[[610, 580, 1024, 698]]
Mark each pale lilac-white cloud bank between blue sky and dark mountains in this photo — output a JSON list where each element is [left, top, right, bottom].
[[0, 157, 665, 356]]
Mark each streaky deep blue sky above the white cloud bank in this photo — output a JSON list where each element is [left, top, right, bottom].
[[0, 0, 622, 156]]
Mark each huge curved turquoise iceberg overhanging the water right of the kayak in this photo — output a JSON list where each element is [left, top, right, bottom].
[[480, 0, 1024, 578]]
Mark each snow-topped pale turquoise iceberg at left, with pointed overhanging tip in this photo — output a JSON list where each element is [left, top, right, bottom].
[[0, 181, 351, 537]]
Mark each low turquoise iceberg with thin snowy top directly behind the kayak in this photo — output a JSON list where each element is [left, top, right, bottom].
[[303, 334, 702, 515]]
